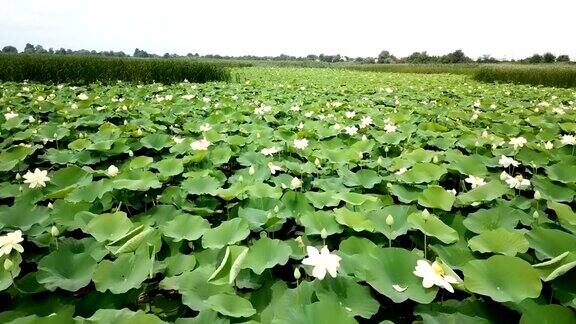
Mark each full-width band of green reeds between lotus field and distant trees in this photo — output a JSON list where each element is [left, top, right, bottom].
[[0, 53, 576, 88]]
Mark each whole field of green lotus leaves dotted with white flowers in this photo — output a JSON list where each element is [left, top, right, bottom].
[[0, 68, 576, 324]]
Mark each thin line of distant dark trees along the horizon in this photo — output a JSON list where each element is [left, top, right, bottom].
[[2, 43, 570, 64]]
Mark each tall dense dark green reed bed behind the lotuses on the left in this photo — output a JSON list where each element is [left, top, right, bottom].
[[0, 54, 230, 84]]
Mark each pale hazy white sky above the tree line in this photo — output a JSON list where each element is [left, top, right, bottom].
[[0, 0, 576, 59]]
